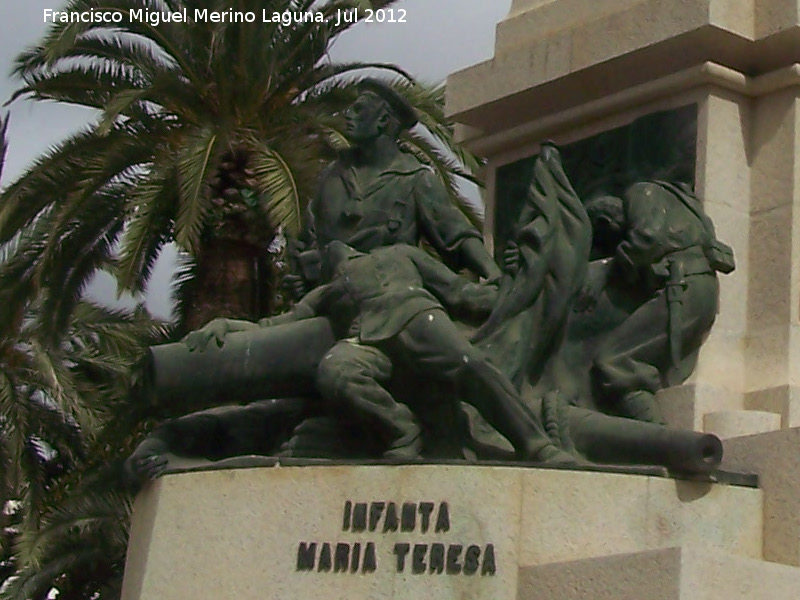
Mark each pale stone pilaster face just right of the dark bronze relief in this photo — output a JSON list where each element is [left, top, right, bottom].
[[660, 89, 751, 433]]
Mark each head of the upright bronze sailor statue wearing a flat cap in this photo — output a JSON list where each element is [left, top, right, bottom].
[[344, 79, 417, 144]]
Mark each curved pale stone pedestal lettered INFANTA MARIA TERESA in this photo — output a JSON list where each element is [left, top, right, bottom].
[[123, 466, 776, 600]]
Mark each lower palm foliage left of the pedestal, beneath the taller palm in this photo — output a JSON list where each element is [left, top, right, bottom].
[[0, 302, 166, 600]]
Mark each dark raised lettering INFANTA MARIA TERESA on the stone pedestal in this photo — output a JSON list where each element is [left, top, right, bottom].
[[297, 500, 497, 576]]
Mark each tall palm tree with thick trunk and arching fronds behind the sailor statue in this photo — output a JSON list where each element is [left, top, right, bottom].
[[0, 0, 475, 332]]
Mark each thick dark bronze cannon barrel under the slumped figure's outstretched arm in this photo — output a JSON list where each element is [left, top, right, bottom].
[[138, 317, 334, 410]]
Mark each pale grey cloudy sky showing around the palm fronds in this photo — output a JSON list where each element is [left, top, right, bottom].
[[0, 0, 511, 318]]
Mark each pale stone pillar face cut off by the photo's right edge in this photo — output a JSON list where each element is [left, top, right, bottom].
[[745, 85, 800, 427]]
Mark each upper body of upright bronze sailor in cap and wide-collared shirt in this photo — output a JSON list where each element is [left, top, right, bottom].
[[288, 80, 500, 292]]
